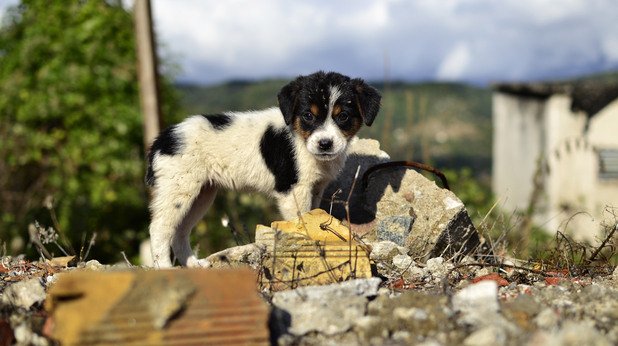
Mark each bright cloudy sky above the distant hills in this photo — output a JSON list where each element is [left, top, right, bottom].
[[0, 0, 618, 84]]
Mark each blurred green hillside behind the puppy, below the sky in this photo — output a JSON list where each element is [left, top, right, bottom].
[[177, 80, 491, 174]]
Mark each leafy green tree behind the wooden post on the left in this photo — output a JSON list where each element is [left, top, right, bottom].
[[0, 0, 175, 260]]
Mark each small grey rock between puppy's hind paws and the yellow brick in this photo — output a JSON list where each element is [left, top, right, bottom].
[[204, 244, 266, 270]]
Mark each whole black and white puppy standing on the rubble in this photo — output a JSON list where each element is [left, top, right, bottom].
[[146, 71, 380, 267]]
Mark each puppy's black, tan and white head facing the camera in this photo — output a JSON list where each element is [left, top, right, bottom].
[[278, 71, 381, 161]]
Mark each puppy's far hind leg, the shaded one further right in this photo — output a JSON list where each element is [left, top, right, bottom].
[[172, 183, 217, 267]]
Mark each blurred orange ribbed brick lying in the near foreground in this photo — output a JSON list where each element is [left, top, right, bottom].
[[46, 269, 268, 345]]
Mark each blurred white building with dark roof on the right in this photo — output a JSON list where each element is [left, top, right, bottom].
[[492, 81, 618, 240]]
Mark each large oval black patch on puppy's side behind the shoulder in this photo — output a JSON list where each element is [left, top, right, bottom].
[[260, 125, 298, 193]]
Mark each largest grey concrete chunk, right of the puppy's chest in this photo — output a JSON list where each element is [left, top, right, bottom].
[[322, 139, 480, 260]]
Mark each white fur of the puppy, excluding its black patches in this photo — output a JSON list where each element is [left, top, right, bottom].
[[150, 107, 347, 267]]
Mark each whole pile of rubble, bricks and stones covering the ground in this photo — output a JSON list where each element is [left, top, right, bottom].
[[0, 141, 618, 346]]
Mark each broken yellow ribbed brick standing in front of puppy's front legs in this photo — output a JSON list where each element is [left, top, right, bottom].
[[255, 209, 372, 291]]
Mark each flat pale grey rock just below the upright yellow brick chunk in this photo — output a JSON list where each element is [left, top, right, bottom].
[[272, 278, 381, 336]]
